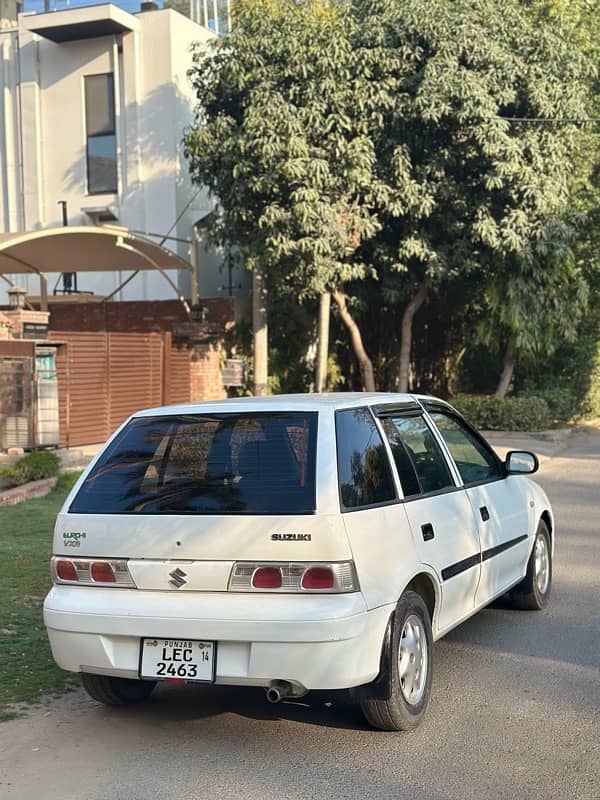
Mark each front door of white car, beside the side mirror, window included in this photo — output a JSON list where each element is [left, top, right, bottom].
[[428, 404, 529, 605]]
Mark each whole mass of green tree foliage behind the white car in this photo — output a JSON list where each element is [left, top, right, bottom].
[[186, 0, 597, 400]]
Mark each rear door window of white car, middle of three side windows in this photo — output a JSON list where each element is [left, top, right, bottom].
[[382, 415, 455, 497]]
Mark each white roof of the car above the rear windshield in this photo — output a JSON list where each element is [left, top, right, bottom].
[[134, 392, 440, 417]]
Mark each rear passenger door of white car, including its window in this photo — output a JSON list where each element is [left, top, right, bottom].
[[378, 408, 481, 632]]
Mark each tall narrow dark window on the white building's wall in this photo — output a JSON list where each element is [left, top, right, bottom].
[[85, 74, 117, 194]]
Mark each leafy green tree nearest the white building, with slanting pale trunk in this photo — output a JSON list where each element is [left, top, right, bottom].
[[186, 0, 377, 389]]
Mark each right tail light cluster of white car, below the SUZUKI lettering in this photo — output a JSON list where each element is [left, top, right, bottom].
[[229, 561, 358, 594]]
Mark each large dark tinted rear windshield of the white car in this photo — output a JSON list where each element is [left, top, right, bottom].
[[69, 412, 317, 514]]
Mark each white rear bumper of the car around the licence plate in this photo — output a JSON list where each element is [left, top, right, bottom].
[[44, 586, 393, 689]]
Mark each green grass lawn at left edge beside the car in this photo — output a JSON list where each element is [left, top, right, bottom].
[[0, 473, 78, 720]]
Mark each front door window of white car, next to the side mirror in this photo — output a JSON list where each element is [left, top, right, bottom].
[[430, 410, 502, 484]]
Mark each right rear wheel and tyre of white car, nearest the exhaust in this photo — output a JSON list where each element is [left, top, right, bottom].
[[360, 591, 433, 731]]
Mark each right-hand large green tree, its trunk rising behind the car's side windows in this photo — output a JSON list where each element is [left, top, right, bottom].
[[356, 0, 586, 391]]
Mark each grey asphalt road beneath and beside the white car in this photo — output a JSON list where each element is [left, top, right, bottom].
[[0, 431, 600, 800]]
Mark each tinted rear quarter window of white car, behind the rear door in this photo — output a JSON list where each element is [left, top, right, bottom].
[[335, 408, 396, 509]]
